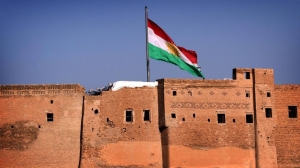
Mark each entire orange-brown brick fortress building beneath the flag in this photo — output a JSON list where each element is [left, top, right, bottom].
[[0, 68, 300, 168]]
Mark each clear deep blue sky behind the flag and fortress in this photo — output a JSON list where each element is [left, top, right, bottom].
[[0, 0, 300, 90]]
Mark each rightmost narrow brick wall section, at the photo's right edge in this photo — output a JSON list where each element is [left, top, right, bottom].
[[275, 85, 300, 167]]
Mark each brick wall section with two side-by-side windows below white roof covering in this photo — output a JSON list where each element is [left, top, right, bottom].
[[82, 87, 162, 167]]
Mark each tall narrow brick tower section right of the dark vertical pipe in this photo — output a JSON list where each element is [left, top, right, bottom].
[[253, 69, 278, 167]]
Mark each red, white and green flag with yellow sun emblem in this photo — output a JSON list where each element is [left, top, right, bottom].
[[148, 19, 204, 78]]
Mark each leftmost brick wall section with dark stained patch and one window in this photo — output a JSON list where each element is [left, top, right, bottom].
[[0, 85, 84, 168]]
